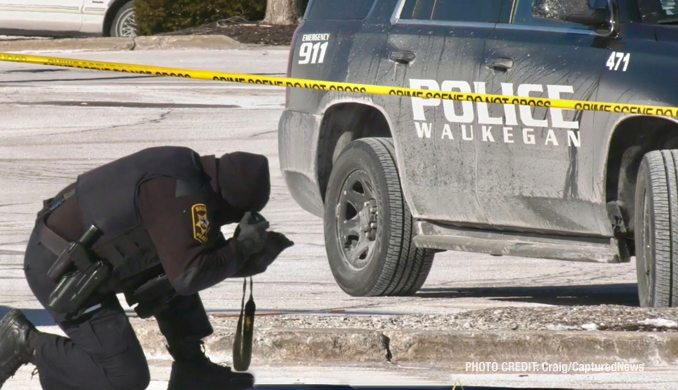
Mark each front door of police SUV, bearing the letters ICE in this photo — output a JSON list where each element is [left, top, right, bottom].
[[477, 0, 611, 235]]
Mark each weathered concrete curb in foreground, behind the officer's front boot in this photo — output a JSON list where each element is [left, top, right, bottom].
[[133, 321, 678, 370]]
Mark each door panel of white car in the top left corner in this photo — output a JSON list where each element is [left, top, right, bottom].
[[0, 0, 84, 32]]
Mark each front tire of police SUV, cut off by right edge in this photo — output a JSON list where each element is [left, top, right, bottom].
[[635, 150, 678, 307]]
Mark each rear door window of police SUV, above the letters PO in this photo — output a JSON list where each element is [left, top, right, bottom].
[[400, 0, 503, 23]]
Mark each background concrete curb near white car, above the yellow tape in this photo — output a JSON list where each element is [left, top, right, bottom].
[[0, 35, 245, 52]]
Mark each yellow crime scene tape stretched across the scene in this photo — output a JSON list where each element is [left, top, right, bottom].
[[0, 53, 678, 117]]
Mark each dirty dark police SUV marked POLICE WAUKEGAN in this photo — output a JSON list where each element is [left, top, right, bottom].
[[279, 0, 678, 307]]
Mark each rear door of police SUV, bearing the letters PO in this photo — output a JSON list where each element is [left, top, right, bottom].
[[387, 0, 510, 222]]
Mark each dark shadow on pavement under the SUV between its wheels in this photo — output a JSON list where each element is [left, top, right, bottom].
[[416, 283, 639, 306]]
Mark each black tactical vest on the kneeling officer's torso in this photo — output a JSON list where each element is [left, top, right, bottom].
[[76, 147, 209, 279]]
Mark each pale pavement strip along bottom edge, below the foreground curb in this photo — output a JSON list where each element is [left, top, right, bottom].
[[7, 361, 678, 390]]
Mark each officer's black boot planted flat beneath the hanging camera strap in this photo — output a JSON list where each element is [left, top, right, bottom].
[[167, 340, 254, 390]]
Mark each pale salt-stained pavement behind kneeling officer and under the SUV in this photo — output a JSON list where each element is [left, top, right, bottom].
[[0, 49, 637, 320]]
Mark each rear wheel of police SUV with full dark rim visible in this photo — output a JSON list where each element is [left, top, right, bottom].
[[325, 138, 434, 296]]
